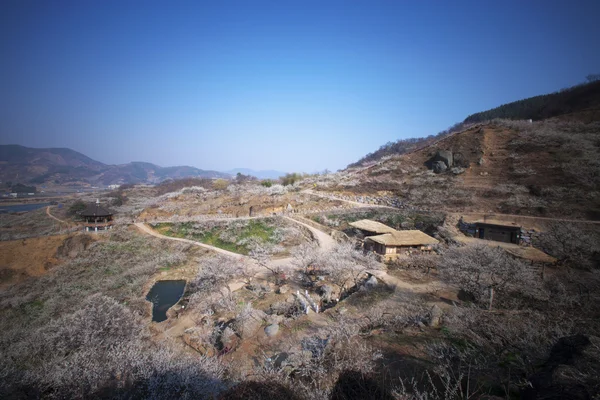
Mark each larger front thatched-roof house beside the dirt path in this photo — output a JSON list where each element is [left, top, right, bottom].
[[364, 230, 438, 259]]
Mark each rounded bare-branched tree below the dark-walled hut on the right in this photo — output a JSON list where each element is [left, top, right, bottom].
[[439, 244, 540, 310]]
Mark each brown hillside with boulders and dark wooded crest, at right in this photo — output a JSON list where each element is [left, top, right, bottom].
[[332, 82, 600, 220]]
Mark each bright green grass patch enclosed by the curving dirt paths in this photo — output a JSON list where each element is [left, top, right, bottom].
[[153, 219, 277, 255]]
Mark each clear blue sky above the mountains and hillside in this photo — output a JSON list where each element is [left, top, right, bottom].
[[0, 0, 600, 172]]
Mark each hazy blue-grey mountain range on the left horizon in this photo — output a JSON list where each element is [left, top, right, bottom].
[[0, 145, 230, 186]]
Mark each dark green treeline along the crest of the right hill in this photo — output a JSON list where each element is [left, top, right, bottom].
[[464, 75, 600, 124]]
